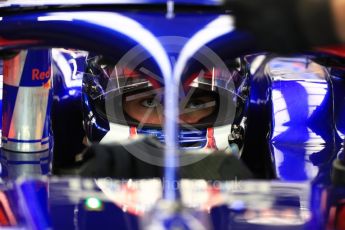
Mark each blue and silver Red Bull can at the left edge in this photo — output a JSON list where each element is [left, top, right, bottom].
[[1, 49, 53, 176]]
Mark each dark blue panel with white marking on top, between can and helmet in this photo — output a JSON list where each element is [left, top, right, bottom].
[[52, 49, 86, 167]]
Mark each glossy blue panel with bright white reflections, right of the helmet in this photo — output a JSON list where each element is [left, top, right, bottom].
[[269, 57, 340, 184]]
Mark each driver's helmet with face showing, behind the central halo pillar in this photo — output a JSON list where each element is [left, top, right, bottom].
[[82, 55, 248, 153]]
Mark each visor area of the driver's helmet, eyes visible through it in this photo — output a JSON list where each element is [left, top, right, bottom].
[[84, 62, 241, 127]]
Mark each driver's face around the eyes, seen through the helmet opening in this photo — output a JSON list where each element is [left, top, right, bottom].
[[123, 90, 216, 125]]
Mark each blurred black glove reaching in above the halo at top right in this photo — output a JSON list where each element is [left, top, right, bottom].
[[226, 0, 339, 53]]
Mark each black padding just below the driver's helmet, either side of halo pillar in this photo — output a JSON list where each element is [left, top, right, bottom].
[[80, 139, 253, 180]]
